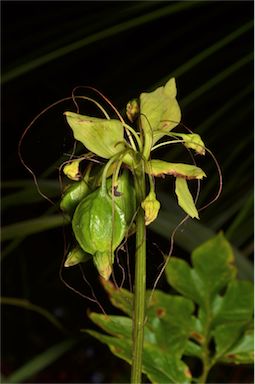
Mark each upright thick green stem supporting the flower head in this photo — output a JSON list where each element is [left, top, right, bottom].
[[131, 166, 146, 384]]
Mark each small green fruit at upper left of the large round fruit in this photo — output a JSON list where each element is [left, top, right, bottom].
[[60, 180, 90, 217]]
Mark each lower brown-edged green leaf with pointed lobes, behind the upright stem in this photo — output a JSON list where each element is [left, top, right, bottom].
[[86, 282, 194, 383]]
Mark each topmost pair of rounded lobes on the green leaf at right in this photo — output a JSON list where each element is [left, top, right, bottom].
[[166, 233, 236, 307]]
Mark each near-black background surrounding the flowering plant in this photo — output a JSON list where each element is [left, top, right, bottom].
[[1, 1, 253, 383]]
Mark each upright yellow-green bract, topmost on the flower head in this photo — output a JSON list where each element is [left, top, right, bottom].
[[140, 78, 181, 144]]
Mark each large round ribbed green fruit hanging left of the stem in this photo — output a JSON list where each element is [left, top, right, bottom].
[[72, 187, 127, 279]]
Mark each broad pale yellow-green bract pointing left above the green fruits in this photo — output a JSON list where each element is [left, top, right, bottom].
[[64, 112, 125, 159]]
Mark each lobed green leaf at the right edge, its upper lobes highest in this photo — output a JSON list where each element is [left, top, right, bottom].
[[166, 233, 253, 366]]
